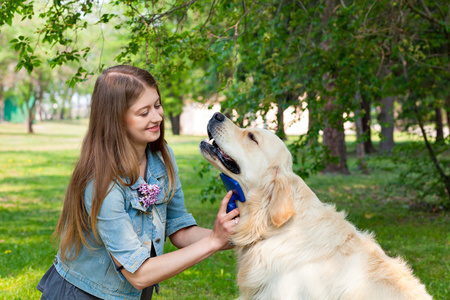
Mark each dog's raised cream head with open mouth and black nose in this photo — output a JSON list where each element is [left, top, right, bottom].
[[200, 113, 294, 241]]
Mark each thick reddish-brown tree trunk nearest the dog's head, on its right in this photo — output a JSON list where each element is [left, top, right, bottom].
[[323, 97, 350, 174]]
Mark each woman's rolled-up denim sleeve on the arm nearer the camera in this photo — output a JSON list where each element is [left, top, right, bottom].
[[85, 183, 150, 273]]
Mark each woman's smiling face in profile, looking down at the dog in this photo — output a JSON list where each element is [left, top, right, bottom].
[[125, 87, 164, 147]]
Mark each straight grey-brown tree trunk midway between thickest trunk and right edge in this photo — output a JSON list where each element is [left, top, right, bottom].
[[378, 96, 394, 153]]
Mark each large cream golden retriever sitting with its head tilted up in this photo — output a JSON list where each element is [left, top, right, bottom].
[[200, 113, 432, 300]]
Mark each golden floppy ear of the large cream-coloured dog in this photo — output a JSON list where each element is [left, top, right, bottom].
[[269, 172, 295, 227]]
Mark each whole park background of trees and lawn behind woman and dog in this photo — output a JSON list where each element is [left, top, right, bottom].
[[0, 0, 450, 299]]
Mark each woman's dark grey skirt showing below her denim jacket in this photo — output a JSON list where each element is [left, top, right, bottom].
[[37, 265, 153, 300]]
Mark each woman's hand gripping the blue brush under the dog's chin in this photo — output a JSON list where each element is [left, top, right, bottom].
[[210, 191, 239, 250]]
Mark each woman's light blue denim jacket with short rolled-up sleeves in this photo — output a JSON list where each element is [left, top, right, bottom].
[[54, 147, 196, 299]]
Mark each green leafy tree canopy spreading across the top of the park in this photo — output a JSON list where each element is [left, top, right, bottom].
[[0, 0, 450, 201]]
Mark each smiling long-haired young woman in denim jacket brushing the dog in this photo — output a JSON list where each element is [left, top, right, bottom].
[[38, 66, 239, 299]]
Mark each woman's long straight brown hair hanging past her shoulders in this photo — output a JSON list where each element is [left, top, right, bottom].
[[53, 65, 175, 260]]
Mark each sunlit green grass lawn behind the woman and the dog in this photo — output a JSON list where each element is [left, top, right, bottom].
[[0, 121, 450, 300]]
